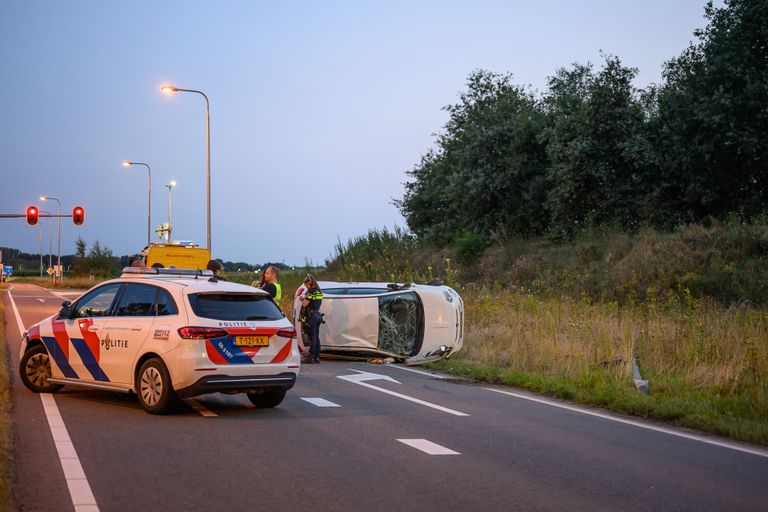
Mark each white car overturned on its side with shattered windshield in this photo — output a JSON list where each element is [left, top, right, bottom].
[[293, 281, 464, 365]]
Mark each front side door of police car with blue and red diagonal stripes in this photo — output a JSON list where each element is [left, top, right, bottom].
[[60, 283, 123, 382]]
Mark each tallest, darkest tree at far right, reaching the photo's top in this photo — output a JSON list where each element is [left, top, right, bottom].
[[654, 0, 768, 223]]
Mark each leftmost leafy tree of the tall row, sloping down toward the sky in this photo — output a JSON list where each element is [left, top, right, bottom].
[[396, 70, 549, 243]]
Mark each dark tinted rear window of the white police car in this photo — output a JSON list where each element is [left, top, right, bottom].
[[189, 293, 284, 320]]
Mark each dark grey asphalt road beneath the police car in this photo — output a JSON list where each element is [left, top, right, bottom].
[[3, 285, 768, 511]]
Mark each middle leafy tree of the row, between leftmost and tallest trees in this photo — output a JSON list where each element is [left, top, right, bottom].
[[544, 57, 652, 236]]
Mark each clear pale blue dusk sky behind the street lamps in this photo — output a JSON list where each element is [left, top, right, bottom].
[[0, 0, 705, 265]]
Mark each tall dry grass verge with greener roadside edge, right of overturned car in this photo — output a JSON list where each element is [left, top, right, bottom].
[[430, 290, 768, 445]]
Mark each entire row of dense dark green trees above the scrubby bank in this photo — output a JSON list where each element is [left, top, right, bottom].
[[396, 0, 768, 244]]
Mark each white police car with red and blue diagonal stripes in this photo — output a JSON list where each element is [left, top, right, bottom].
[[19, 267, 300, 414]]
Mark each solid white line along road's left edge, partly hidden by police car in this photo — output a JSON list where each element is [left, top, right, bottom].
[[8, 291, 99, 512]]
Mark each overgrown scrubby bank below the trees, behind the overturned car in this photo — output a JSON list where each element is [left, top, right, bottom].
[[326, 217, 768, 306]]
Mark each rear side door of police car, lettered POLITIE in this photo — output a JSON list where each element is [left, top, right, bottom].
[[101, 283, 160, 384]]
